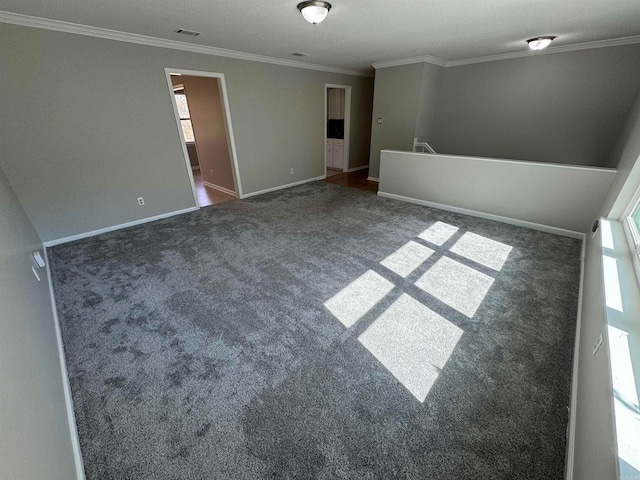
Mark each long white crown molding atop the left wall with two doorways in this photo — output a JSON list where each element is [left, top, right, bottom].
[[0, 11, 373, 78]]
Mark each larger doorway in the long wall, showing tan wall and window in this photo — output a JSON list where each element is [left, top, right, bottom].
[[165, 68, 242, 207]]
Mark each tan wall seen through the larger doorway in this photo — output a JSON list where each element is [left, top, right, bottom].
[[179, 75, 236, 192]]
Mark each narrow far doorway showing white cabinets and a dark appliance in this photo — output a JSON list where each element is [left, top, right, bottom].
[[324, 83, 351, 177]]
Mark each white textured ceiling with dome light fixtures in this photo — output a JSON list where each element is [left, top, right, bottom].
[[0, 0, 640, 71]]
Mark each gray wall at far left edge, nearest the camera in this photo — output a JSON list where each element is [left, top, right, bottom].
[[0, 164, 75, 480]]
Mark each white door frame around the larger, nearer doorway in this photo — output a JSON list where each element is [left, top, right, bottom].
[[164, 67, 244, 204]]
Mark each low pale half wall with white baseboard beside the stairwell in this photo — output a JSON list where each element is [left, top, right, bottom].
[[378, 151, 615, 232]]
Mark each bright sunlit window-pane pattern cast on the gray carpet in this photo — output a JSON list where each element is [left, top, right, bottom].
[[324, 222, 512, 402]]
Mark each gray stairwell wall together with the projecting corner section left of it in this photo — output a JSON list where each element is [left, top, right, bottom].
[[370, 45, 640, 176]]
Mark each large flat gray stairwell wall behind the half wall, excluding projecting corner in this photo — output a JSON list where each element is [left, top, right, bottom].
[[433, 45, 640, 167]]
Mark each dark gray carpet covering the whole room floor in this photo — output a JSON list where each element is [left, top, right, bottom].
[[49, 183, 580, 480]]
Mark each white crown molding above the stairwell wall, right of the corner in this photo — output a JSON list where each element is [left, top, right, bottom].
[[371, 35, 640, 70]]
